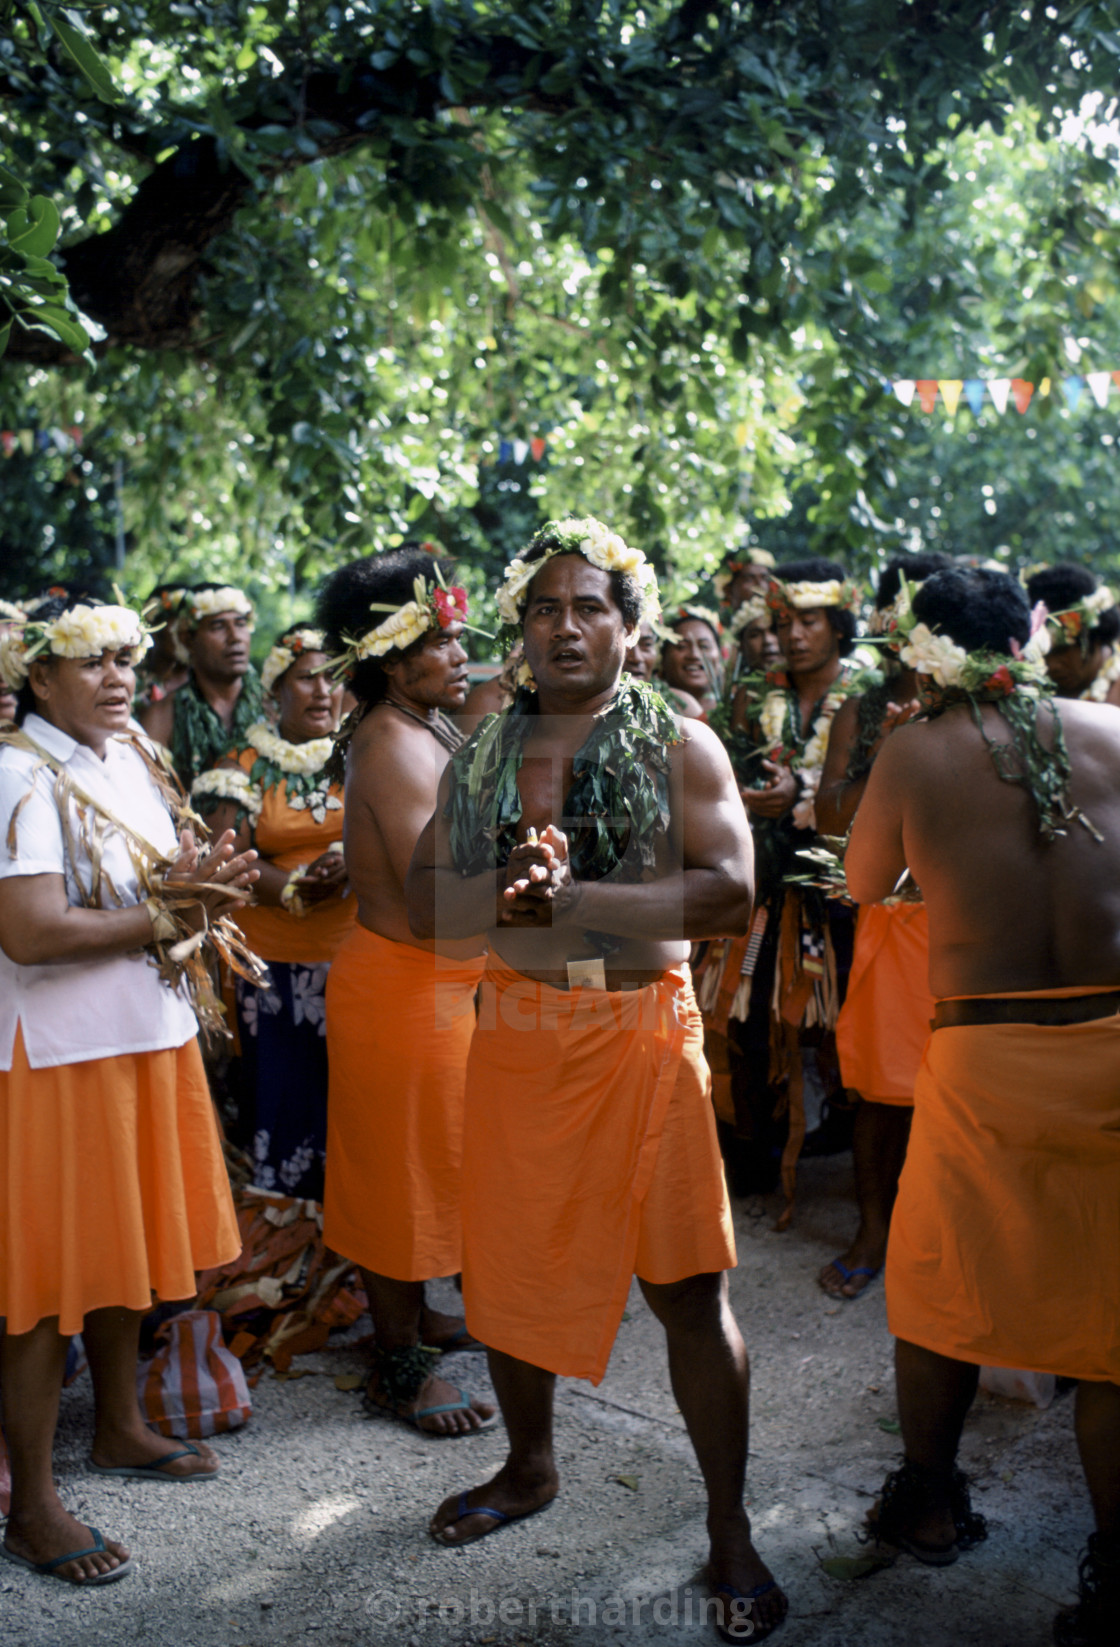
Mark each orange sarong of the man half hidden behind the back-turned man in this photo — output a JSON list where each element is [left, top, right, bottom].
[[837, 904, 934, 1105]]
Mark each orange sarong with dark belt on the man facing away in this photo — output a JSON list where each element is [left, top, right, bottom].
[[886, 988, 1120, 1382]]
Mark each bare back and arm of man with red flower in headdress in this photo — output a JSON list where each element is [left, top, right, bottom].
[[343, 702, 481, 957]]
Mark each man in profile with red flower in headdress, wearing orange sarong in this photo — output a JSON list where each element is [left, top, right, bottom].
[[312, 545, 496, 1436]]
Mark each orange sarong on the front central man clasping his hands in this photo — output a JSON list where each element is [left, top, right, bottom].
[[463, 957, 735, 1383]]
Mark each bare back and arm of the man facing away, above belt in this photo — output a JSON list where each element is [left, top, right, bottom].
[[845, 702, 1120, 998]]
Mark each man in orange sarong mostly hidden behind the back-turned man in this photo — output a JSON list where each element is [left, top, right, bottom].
[[817, 553, 950, 1298]]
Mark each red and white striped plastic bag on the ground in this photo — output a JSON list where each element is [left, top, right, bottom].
[[137, 1309, 252, 1441]]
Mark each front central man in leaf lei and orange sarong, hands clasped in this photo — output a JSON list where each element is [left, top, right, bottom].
[[408, 520, 786, 1640]]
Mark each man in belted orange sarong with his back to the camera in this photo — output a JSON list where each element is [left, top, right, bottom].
[[847, 567, 1120, 1647]]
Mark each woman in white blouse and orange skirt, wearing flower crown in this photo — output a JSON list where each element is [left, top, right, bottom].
[[0, 600, 255, 1584]]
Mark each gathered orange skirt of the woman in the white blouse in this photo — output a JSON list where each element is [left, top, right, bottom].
[[0, 1031, 240, 1334]]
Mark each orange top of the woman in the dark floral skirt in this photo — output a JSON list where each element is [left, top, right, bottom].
[[227, 749, 349, 965]]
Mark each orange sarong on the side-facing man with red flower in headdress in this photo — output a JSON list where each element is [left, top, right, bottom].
[[323, 926, 484, 1281]]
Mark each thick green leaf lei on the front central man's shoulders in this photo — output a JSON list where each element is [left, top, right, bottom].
[[446, 675, 684, 915]]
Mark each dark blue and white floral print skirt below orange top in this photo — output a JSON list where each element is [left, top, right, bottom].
[[237, 960, 331, 1201]]
